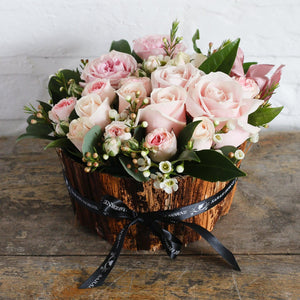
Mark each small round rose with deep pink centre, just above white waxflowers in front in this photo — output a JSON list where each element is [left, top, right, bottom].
[[145, 128, 177, 162]]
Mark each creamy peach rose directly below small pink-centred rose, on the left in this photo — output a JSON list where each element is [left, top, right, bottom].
[[75, 94, 111, 128]]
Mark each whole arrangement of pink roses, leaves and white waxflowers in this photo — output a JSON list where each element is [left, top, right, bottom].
[[19, 21, 283, 193]]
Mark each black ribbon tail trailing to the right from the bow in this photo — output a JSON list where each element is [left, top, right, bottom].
[[182, 222, 241, 271]]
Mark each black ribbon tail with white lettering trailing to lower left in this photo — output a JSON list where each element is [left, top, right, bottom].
[[79, 219, 139, 289]]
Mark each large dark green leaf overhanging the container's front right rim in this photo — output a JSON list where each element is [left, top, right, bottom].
[[184, 150, 246, 182]]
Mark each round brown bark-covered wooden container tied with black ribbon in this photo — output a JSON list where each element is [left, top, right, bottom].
[[57, 149, 241, 250]]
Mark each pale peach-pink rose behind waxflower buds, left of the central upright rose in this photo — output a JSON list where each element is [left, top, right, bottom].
[[117, 80, 147, 113]]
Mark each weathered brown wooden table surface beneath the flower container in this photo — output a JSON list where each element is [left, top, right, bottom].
[[0, 132, 300, 300]]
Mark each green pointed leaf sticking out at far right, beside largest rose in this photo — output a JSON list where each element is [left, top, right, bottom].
[[248, 106, 283, 126]]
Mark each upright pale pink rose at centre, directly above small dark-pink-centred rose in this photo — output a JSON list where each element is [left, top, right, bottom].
[[136, 86, 187, 135]]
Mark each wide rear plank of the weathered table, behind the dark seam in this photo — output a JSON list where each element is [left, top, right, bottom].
[[0, 132, 300, 255]]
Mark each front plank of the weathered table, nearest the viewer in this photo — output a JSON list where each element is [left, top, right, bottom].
[[0, 255, 300, 300]]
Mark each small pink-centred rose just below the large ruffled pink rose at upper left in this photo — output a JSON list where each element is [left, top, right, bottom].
[[81, 79, 116, 103]]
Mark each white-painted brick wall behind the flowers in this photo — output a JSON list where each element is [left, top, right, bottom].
[[0, 0, 300, 136]]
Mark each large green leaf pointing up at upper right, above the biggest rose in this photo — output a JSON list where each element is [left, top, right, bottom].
[[199, 39, 240, 74]]
